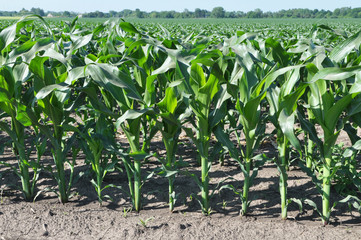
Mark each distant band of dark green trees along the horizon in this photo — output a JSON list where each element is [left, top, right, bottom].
[[0, 7, 361, 18]]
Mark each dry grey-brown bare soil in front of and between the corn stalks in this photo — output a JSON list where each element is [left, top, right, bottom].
[[0, 129, 361, 239]]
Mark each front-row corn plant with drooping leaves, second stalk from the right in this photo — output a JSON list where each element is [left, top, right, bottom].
[[265, 38, 306, 219]]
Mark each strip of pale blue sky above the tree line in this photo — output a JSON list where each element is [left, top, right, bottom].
[[0, 0, 361, 13]]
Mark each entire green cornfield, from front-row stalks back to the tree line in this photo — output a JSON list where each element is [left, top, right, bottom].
[[0, 15, 361, 225]]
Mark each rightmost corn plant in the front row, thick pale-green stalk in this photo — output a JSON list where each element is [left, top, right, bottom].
[[299, 63, 361, 225]]
